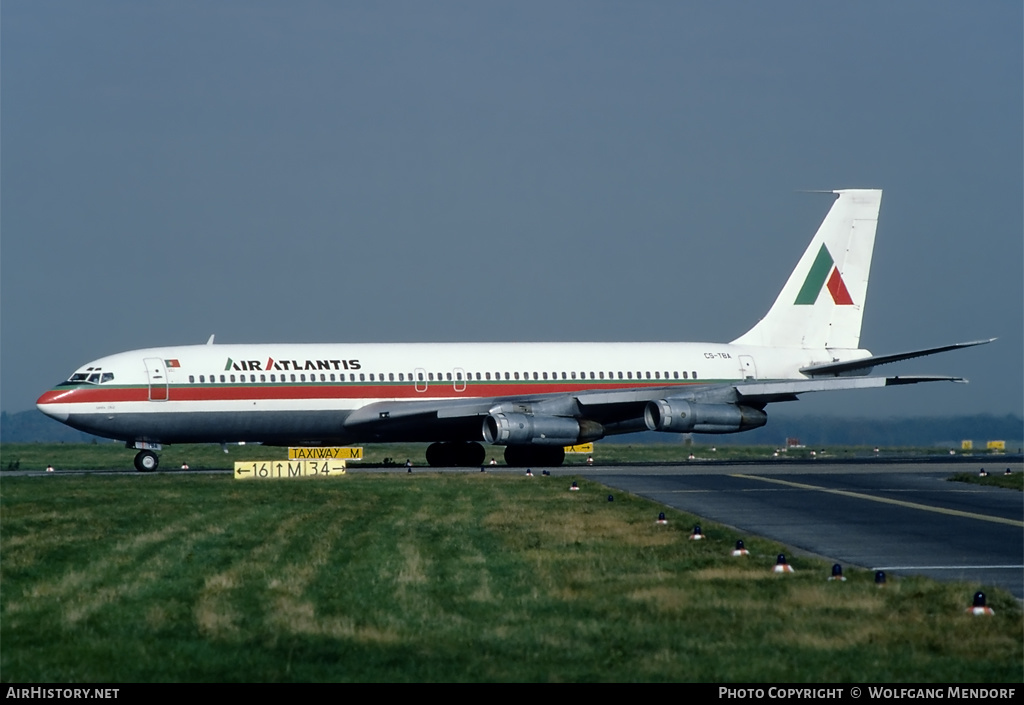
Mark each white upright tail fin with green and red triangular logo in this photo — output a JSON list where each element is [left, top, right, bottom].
[[732, 189, 882, 349]]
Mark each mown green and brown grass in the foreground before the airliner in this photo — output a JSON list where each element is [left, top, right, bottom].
[[0, 471, 1024, 683]]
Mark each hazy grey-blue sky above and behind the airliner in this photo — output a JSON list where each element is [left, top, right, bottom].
[[0, 0, 1024, 415]]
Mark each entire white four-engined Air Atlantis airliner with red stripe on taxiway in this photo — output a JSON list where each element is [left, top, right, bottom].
[[37, 190, 989, 471]]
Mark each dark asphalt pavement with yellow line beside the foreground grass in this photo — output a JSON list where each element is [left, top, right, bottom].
[[585, 462, 1024, 599]]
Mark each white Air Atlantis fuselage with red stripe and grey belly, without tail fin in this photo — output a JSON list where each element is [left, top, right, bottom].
[[38, 343, 868, 443]]
